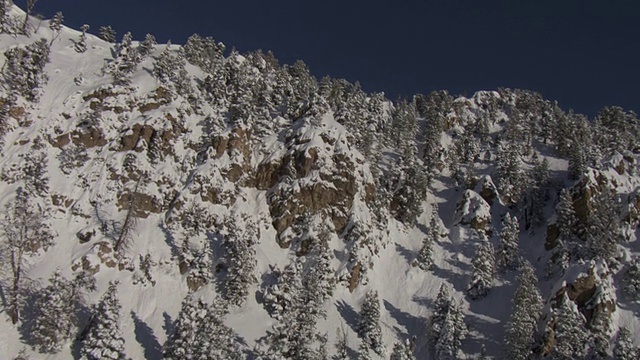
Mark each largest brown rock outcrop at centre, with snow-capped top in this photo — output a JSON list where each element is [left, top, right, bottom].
[[254, 118, 375, 248]]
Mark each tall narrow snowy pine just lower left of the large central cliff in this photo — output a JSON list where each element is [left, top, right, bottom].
[[222, 218, 258, 306]]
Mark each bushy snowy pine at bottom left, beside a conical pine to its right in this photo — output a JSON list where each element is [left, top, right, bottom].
[[32, 271, 95, 353]]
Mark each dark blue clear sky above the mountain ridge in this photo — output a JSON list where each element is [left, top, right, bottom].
[[20, 0, 640, 116]]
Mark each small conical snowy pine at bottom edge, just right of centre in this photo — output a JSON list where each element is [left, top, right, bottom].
[[358, 290, 384, 356]]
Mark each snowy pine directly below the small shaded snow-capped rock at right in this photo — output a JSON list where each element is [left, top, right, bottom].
[[467, 238, 496, 300]]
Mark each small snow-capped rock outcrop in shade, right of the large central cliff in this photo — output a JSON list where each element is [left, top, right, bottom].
[[454, 190, 492, 235]]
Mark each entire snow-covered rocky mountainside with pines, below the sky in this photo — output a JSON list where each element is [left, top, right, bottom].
[[0, 0, 640, 359]]
